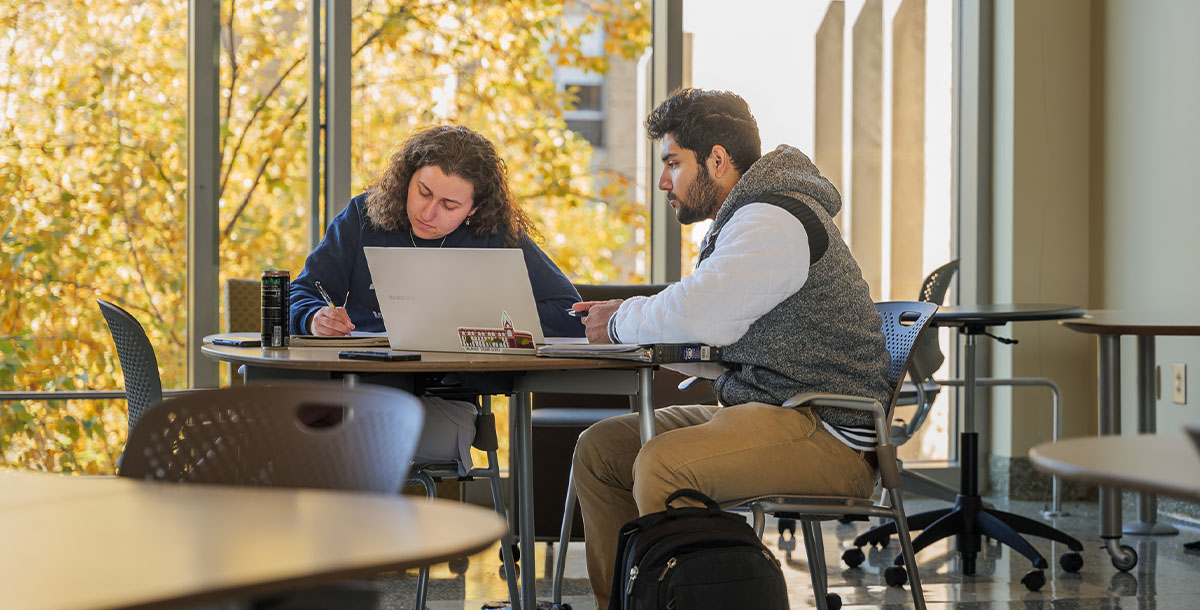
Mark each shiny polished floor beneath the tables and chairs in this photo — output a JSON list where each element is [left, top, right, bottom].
[[378, 498, 1200, 610]]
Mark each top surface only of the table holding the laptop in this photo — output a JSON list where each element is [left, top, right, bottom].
[[200, 337, 646, 372]]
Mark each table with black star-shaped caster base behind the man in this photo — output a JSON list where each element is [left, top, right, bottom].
[[854, 304, 1084, 591]]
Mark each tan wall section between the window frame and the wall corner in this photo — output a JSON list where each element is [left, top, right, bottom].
[[984, 0, 1096, 456]]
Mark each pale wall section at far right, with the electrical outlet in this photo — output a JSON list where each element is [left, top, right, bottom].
[[1092, 0, 1200, 432]]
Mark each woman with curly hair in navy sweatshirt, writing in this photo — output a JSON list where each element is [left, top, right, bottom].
[[290, 126, 583, 336]]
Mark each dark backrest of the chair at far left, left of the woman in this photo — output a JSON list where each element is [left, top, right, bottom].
[[96, 299, 162, 430]]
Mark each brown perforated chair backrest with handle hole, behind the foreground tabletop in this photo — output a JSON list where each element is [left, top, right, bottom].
[[120, 383, 424, 494]]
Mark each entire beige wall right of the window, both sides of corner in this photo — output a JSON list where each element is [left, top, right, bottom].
[[991, 0, 1200, 456]]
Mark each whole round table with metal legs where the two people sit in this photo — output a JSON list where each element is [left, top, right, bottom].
[[200, 333, 655, 610]]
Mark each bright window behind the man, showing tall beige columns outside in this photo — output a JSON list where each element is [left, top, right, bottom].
[[682, 0, 953, 459]]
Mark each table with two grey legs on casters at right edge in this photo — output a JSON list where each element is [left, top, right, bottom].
[[1060, 310, 1200, 570]]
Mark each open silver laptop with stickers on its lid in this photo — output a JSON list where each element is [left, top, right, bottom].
[[362, 246, 545, 355]]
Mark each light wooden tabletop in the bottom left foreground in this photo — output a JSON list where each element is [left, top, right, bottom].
[[0, 471, 506, 610]]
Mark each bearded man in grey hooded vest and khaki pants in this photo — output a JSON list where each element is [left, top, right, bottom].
[[574, 89, 890, 608]]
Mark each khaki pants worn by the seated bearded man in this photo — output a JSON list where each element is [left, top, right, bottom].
[[574, 402, 876, 610]]
